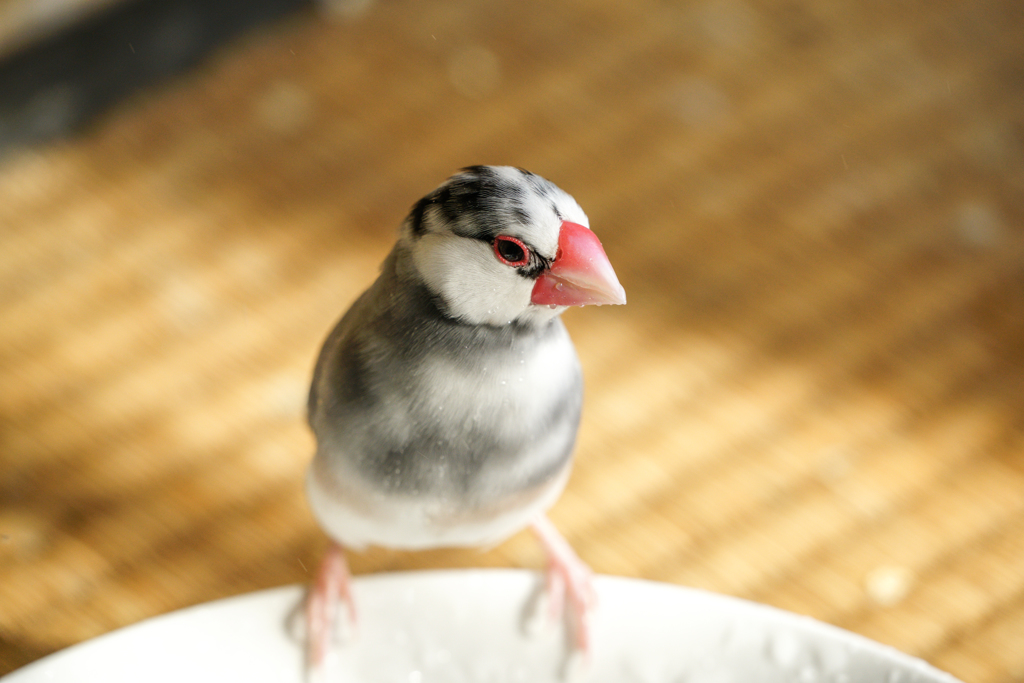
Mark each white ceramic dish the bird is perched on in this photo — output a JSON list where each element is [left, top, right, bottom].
[[3, 570, 956, 683]]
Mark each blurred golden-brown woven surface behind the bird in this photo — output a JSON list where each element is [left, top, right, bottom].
[[0, 0, 1024, 683]]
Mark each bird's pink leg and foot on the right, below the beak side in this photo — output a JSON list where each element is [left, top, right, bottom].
[[532, 517, 597, 656]]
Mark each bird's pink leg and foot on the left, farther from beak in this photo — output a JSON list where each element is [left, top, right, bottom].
[[306, 543, 355, 672]]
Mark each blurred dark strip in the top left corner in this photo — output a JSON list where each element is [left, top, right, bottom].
[[0, 0, 311, 158]]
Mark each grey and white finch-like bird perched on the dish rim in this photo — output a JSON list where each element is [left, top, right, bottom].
[[305, 166, 626, 671]]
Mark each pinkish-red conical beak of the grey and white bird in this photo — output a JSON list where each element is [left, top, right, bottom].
[[530, 220, 626, 306]]
